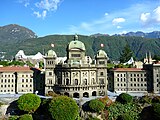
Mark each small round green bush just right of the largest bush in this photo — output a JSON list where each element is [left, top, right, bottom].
[[89, 99, 105, 113]]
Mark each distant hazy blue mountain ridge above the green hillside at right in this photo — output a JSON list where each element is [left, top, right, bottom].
[[116, 31, 160, 38]]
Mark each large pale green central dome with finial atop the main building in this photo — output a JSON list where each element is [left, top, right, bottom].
[[68, 35, 86, 51]]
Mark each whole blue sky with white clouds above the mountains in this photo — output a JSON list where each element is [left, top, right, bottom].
[[0, 0, 160, 36]]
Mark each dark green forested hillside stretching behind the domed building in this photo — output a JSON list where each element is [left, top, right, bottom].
[[0, 35, 160, 60]]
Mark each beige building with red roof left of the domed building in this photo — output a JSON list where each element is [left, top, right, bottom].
[[0, 66, 33, 94]]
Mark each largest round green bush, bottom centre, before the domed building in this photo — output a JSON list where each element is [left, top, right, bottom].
[[49, 96, 79, 120]]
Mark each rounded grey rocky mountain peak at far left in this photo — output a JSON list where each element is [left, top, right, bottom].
[[0, 24, 37, 43]]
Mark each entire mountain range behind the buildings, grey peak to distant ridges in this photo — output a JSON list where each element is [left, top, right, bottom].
[[0, 24, 160, 60]]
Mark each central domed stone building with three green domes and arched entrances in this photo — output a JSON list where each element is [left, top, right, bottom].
[[45, 35, 108, 98]]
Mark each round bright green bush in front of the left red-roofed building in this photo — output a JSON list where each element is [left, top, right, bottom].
[[17, 93, 41, 113]]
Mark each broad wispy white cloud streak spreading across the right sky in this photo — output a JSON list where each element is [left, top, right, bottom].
[[67, 1, 160, 35]]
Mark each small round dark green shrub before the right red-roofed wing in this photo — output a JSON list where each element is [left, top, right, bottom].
[[116, 93, 133, 104]]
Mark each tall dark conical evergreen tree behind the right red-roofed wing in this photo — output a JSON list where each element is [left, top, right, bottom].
[[120, 44, 133, 63]]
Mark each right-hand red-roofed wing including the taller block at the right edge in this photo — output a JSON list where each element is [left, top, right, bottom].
[[108, 55, 160, 93]]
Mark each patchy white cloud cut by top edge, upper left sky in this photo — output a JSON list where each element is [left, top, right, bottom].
[[35, 0, 60, 11]]
